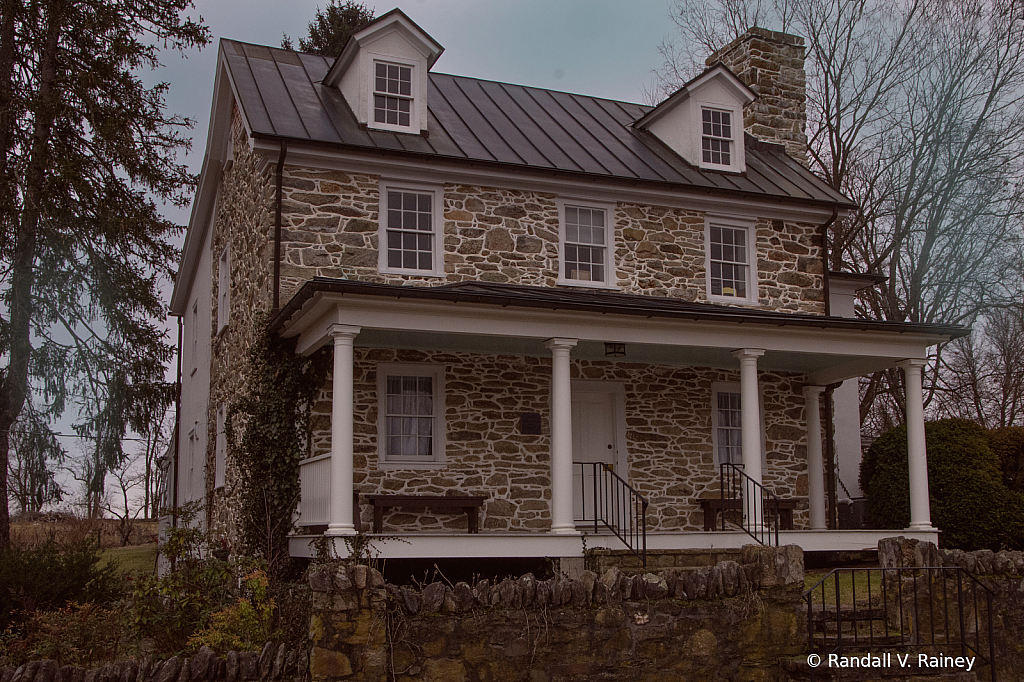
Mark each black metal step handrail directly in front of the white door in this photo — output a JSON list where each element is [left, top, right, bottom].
[[572, 462, 649, 566]]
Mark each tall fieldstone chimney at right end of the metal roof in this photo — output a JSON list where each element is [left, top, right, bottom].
[[705, 27, 807, 166]]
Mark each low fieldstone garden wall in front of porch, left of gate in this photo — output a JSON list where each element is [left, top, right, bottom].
[[309, 547, 806, 682]]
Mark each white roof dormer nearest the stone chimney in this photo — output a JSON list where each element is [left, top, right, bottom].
[[633, 65, 757, 173]]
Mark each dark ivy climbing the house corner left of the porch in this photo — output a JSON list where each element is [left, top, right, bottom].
[[225, 333, 331, 573]]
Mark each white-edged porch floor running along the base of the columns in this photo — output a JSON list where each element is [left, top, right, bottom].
[[290, 530, 939, 559]]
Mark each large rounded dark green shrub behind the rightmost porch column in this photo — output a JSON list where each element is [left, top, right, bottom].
[[860, 419, 1020, 550]]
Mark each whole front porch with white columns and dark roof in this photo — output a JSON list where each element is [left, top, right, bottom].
[[271, 281, 951, 557]]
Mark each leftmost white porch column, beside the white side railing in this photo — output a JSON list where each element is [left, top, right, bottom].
[[325, 325, 359, 536]]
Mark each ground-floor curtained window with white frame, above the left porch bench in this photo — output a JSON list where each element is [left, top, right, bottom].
[[377, 364, 444, 467]]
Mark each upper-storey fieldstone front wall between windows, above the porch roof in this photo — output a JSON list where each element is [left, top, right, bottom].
[[282, 175, 824, 314]]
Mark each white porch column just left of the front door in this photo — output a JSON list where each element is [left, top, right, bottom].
[[544, 339, 579, 535]]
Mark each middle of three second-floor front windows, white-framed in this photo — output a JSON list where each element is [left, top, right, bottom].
[[558, 201, 614, 288]]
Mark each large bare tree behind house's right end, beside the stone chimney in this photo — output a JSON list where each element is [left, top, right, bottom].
[[657, 0, 1024, 430]]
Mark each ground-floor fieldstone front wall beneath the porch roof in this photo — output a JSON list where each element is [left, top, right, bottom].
[[299, 347, 807, 532]]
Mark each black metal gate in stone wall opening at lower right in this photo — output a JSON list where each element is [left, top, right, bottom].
[[804, 566, 995, 682]]
